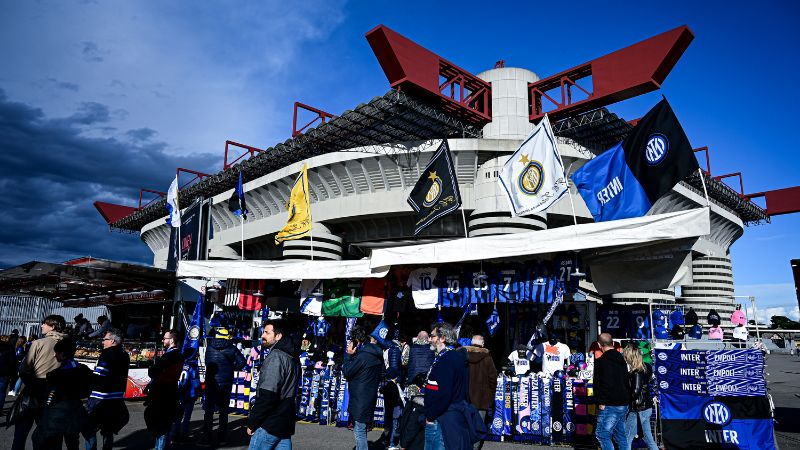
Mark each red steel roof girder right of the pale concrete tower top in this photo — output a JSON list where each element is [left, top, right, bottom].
[[528, 25, 694, 122]]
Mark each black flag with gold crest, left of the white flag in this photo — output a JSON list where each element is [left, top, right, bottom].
[[408, 139, 461, 235]]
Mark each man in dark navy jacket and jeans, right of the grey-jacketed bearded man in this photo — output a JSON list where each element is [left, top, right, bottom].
[[342, 326, 383, 450]]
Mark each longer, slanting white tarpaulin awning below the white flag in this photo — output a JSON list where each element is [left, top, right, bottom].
[[370, 208, 711, 267]]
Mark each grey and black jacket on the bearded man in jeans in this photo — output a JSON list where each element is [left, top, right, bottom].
[[247, 336, 300, 439]]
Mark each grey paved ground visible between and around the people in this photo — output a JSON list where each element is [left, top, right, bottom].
[[0, 355, 800, 450]]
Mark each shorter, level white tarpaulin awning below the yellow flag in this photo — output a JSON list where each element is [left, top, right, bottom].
[[177, 259, 389, 280]]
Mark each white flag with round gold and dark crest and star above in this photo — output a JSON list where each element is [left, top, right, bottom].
[[498, 116, 567, 216]]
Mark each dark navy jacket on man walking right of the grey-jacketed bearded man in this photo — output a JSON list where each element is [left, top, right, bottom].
[[342, 344, 383, 423]]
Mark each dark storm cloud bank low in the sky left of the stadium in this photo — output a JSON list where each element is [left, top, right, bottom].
[[0, 89, 220, 267]]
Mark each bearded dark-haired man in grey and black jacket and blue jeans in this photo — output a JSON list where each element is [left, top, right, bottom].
[[247, 321, 300, 450]]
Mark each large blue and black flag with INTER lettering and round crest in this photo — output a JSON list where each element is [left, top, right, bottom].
[[572, 99, 700, 222]]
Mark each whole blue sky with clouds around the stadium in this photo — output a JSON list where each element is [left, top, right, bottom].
[[0, 0, 800, 324]]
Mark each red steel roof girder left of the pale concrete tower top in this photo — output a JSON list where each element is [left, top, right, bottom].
[[366, 25, 492, 126]]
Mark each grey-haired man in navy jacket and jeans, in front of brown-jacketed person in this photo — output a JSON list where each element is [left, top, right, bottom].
[[425, 322, 486, 450]]
